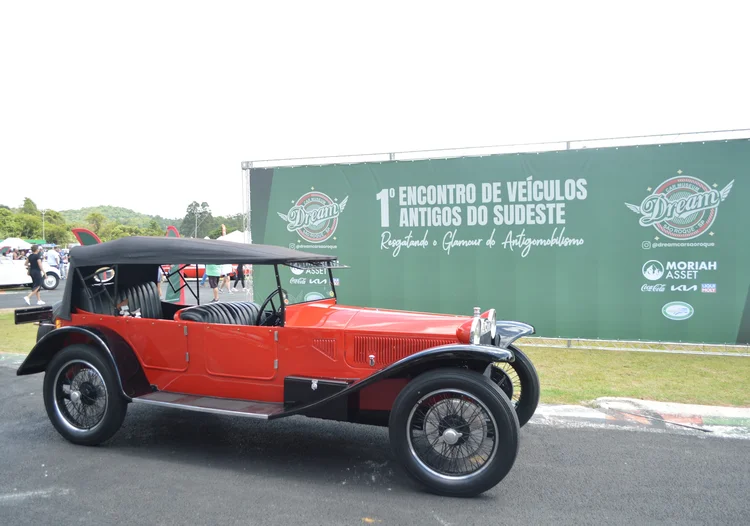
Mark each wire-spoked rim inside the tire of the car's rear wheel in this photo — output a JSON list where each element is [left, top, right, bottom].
[[54, 360, 108, 431]]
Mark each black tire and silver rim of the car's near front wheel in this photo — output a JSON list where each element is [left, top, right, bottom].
[[388, 369, 520, 497]]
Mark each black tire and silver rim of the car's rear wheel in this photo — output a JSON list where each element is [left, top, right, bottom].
[[44, 345, 127, 446]]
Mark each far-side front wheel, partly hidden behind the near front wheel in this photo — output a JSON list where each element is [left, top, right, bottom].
[[490, 345, 540, 427]]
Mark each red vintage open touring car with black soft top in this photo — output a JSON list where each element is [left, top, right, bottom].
[[15, 237, 539, 496]]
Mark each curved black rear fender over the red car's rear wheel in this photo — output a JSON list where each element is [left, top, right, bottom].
[[16, 326, 152, 401]]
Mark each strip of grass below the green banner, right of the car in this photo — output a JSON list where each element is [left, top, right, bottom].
[[522, 347, 750, 407]]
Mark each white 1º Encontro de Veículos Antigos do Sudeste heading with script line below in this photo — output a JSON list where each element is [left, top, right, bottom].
[[375, 176, 588, 257]]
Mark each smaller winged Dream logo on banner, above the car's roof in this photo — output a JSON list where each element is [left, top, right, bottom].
[[277, 191, 349, 243]]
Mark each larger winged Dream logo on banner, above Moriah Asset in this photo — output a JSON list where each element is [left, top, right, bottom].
[[625, 176, 734, 240]]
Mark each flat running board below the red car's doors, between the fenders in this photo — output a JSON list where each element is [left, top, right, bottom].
[[133, 391, 284, 420]]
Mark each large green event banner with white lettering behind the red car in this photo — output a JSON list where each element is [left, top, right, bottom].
[[251, 140, 750, 344]]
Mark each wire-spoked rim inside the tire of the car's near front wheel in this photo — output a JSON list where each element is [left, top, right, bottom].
[[407, 389, 498, 479]]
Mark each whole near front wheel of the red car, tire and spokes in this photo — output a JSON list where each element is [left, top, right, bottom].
[[389, 369, 519, 497]]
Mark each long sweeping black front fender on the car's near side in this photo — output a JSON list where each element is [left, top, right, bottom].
[[269, 343, 513, 420]]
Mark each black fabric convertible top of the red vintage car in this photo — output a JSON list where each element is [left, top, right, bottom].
[[70, 236, 336, 267]]
